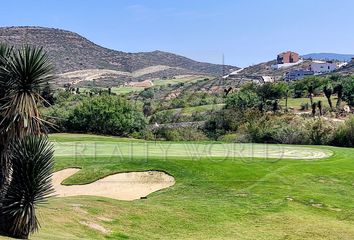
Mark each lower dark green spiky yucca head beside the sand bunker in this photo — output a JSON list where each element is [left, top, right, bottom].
[[1, 136, 54, 238]]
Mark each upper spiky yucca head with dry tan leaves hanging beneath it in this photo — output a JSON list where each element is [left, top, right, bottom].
[[0, 46, 54, 137]]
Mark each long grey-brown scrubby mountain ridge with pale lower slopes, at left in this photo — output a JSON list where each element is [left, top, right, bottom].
[[0, 27, 238, 86]]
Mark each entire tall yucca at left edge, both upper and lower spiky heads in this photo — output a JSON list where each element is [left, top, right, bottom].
[[0, 45, 53, 238]]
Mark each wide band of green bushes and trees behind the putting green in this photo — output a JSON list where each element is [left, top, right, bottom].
[[39, 76, 354, 146]]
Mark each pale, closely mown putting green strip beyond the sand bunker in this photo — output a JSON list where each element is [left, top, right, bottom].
[[54, 136, 332, 160]]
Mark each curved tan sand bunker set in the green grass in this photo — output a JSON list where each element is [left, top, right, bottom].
[[53, 168, 175, 200]]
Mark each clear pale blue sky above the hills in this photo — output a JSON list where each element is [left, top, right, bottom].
[[0, 0, 354, 66]]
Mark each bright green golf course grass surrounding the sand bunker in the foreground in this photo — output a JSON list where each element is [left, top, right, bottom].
[[3, 134, 354, 240]]
